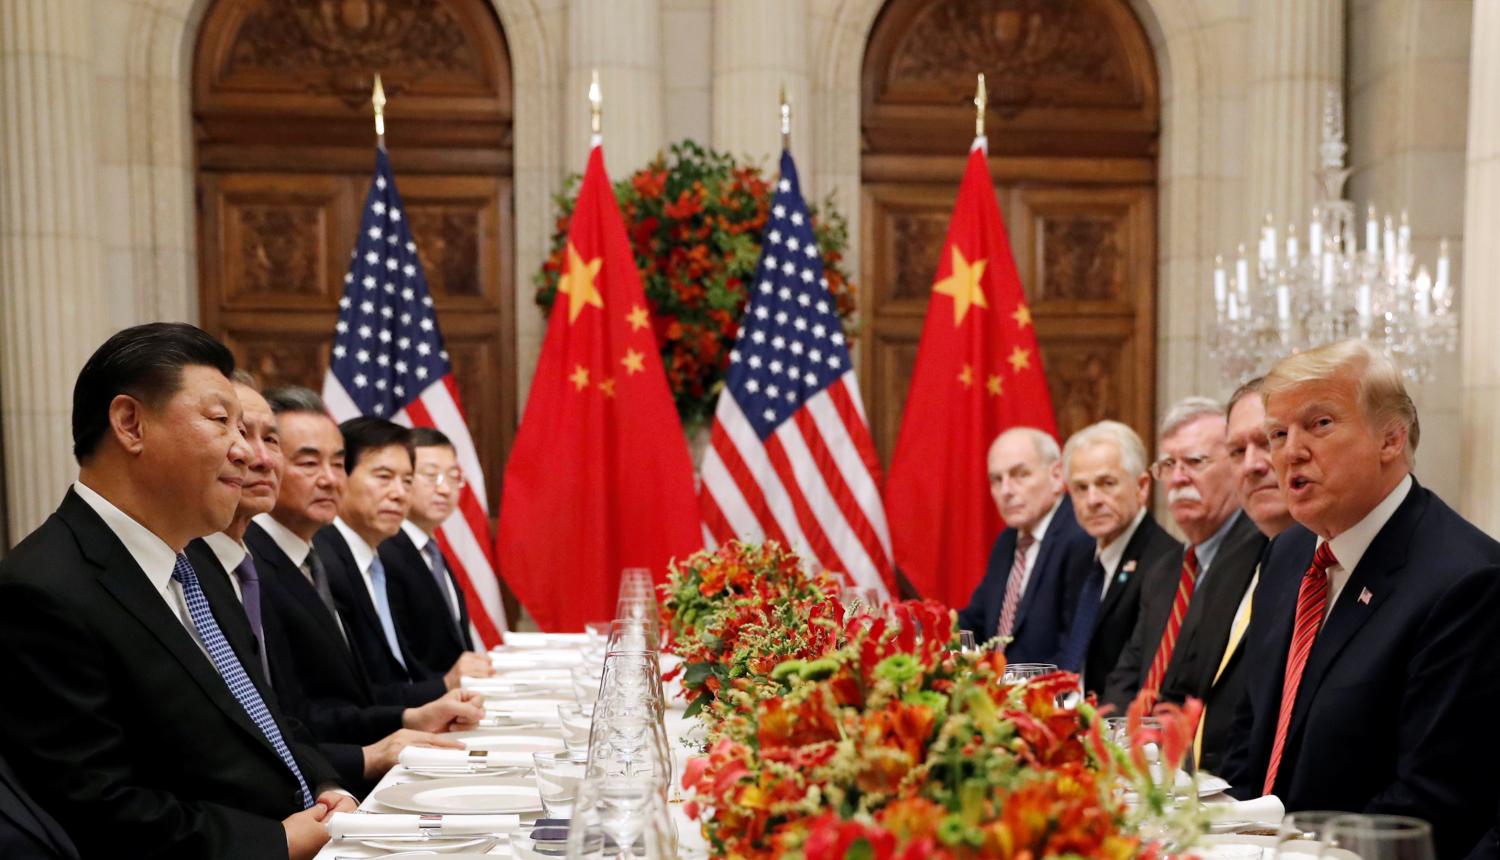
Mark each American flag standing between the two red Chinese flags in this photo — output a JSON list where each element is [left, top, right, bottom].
[[699, 152, 893, 597]]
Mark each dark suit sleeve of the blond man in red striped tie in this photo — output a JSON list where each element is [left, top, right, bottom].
[[1367, 567, 1500, 857]]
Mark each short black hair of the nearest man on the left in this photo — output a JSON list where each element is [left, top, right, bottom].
[[74, 323, 234, 465]]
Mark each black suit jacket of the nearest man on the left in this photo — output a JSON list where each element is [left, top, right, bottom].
[[0, 491, 336, 858]]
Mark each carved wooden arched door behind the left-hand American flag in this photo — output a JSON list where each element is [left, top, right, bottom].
[[194, 0, 516, 512]]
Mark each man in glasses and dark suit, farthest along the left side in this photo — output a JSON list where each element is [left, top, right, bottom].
[[380, 428, 482, 672]]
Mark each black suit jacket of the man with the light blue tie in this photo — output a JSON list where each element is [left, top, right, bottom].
[[312, 525, 447, 705]]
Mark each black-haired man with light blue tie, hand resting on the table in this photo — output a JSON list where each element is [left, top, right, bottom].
[[312, 416, 494, 701]]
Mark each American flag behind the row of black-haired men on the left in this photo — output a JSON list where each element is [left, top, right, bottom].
[[323, 149, 506, 647]]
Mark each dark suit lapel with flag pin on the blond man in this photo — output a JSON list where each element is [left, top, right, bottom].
[[1287, 480, 1427, 737]]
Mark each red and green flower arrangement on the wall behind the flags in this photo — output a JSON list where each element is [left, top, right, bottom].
[[533, 141, 855, 431]]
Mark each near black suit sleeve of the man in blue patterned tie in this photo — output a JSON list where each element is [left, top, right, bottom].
[[0, 582, 289, 860]]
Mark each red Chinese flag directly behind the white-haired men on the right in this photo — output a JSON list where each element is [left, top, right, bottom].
[[885, 138, 1058, 606]]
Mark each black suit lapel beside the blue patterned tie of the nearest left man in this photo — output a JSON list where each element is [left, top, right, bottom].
[[57, 491, 281, 761]]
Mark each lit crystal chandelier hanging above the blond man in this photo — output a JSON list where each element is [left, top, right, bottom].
[[1209, 90, 1458, 383]]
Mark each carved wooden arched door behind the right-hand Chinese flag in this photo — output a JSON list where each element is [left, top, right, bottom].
[[858, 0, 1158, 459]]
